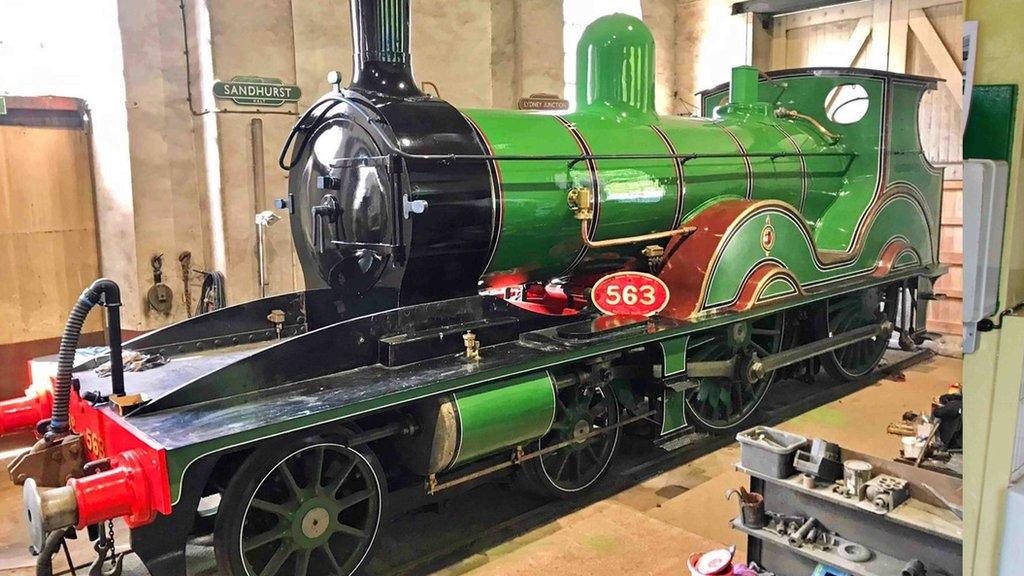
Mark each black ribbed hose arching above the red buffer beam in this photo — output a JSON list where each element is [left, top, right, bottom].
[[49, 278, 124, 435]]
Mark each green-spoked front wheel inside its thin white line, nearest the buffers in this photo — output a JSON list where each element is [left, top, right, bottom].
[[239, 444, 381, 576]]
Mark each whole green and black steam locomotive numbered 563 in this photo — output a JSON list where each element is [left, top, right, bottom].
[[3, 0, 943, 576]]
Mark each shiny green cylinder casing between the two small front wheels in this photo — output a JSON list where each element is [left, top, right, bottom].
[[452, 371, 555, 466]]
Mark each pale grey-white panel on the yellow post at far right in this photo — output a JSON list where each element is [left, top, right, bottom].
[[964, 159, 1008, 354]]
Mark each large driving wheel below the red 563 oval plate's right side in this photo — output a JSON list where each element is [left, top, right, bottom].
[[686, 313, 785, 434]]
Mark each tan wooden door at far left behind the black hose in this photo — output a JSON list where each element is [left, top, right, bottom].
[[0, 96, 102, 398]]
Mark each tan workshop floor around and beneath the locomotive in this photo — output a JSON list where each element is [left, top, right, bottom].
[[0, 357, 961, 576]]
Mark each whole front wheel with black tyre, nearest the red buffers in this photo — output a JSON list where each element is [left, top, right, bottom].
[[214, 440, 387, 576]]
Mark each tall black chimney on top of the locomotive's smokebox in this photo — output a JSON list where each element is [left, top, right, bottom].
[[351, 0, 423, 97]]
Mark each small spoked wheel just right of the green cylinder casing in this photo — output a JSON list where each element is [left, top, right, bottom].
[[524, 384, 622, 498]]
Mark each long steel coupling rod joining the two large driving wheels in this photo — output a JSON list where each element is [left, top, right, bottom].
[[686, 320, 893, 382]]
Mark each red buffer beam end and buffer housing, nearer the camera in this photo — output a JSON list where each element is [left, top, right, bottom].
[[69, 392, 171, 528]]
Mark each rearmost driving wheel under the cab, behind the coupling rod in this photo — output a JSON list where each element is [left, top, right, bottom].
[[824, 290, 889, 378]]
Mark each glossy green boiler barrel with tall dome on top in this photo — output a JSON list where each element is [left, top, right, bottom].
[[463, 14, 843, 288]]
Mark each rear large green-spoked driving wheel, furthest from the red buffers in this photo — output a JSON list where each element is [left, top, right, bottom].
[[818, 288, 897, 381]]
